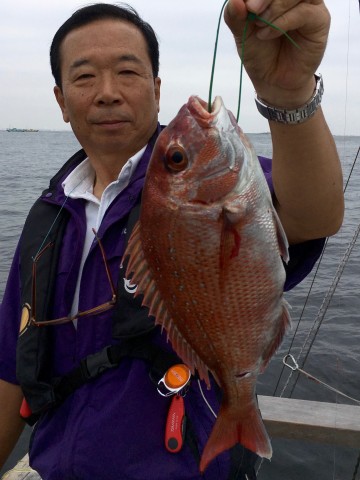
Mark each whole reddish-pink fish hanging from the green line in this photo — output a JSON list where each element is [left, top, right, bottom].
[[125, 96, 290, 471]]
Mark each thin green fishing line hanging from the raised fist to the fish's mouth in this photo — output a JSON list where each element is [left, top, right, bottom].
[[208, 0, 300, 122]]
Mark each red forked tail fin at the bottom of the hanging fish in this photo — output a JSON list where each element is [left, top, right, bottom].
[[200, 406, 272, 473]]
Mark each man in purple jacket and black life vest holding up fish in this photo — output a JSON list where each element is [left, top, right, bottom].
[[0, 0, 343, 480]]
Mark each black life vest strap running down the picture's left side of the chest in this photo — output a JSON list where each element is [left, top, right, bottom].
[[16, 151, 85, 411]]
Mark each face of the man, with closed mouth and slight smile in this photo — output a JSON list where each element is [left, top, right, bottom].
[[54, 19, 160, 160]]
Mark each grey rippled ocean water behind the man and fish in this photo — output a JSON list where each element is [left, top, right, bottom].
[[0, 131, 360, 480]]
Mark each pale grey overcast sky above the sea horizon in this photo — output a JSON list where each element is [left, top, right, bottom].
[[0, 0, 360, 135]]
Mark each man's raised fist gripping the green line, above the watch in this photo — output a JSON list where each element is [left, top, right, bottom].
[[224, 0, 330, 107]]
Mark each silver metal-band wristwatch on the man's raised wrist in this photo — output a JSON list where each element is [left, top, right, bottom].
[[255, 74, 324, 125]]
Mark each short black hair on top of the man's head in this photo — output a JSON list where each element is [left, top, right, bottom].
[[50, 3, 159, 88]]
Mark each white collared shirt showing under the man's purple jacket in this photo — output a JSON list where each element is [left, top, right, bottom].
[[62, 146, 146, 326]]
